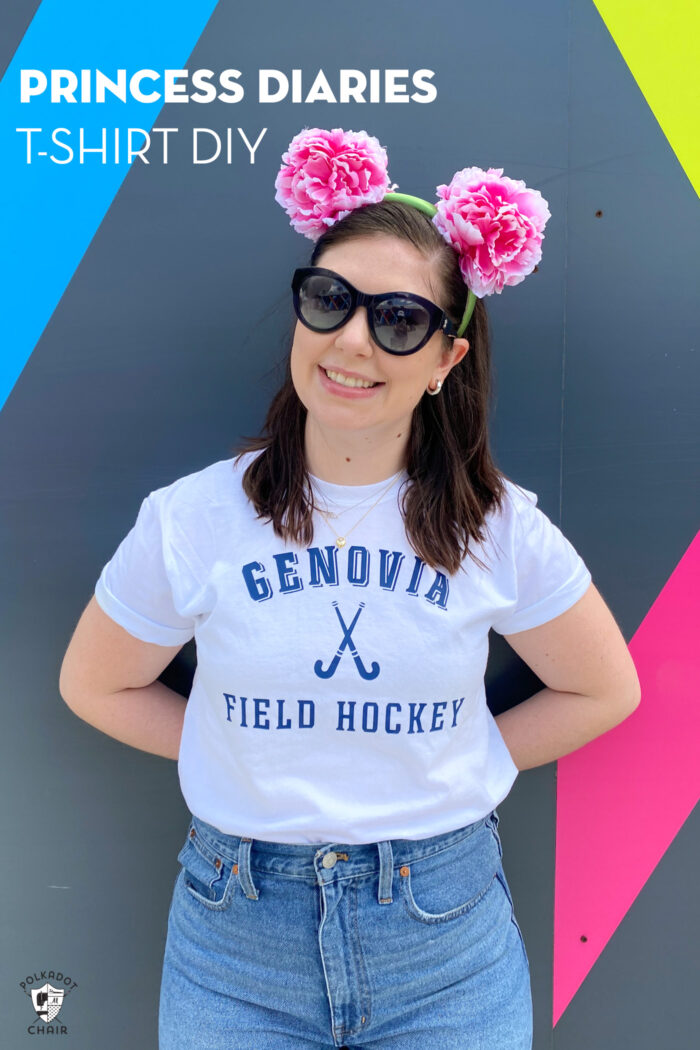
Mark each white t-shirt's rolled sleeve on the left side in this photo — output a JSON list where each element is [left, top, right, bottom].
[[94, 483, 200, 646]]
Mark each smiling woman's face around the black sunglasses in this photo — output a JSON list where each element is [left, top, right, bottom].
[[291, 234, 469, 444]]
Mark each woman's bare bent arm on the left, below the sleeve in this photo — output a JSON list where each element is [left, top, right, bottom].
[[59, 595, 187, 759]]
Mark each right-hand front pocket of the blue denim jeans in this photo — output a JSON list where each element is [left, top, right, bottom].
[[399, 823, 501, 923]]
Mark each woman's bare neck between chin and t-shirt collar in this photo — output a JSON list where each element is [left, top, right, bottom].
[[304, 416, 408, 485]]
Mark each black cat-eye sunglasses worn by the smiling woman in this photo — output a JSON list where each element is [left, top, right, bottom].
[[292, 266, 457, 354]]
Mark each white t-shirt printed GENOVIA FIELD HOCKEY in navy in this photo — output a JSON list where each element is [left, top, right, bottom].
[[96, 453, 591, 844]]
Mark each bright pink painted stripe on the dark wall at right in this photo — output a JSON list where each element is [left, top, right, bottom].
[[552, 533, 700, 1025]]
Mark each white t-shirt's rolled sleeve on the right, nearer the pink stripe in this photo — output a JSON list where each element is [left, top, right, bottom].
[[492, 480, 591, 634]]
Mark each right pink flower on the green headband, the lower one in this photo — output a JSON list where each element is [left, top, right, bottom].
[[432, 168, 551, 298]]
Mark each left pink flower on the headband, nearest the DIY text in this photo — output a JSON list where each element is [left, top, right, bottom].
[[275, 128, 389, 240]]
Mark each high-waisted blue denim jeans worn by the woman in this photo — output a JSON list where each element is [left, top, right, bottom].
[[158, 810, 532, 1050]]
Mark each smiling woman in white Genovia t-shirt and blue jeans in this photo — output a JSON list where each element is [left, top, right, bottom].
[[61, 129, 639, 1050]]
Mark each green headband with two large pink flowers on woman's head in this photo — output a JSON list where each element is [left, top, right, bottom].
[[275, 128, 551, 336]]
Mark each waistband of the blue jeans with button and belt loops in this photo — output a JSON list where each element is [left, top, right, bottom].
[[189, 810, 499, 904]]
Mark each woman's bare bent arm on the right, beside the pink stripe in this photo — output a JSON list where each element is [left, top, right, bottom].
[[495, 584, 641, 770]]
